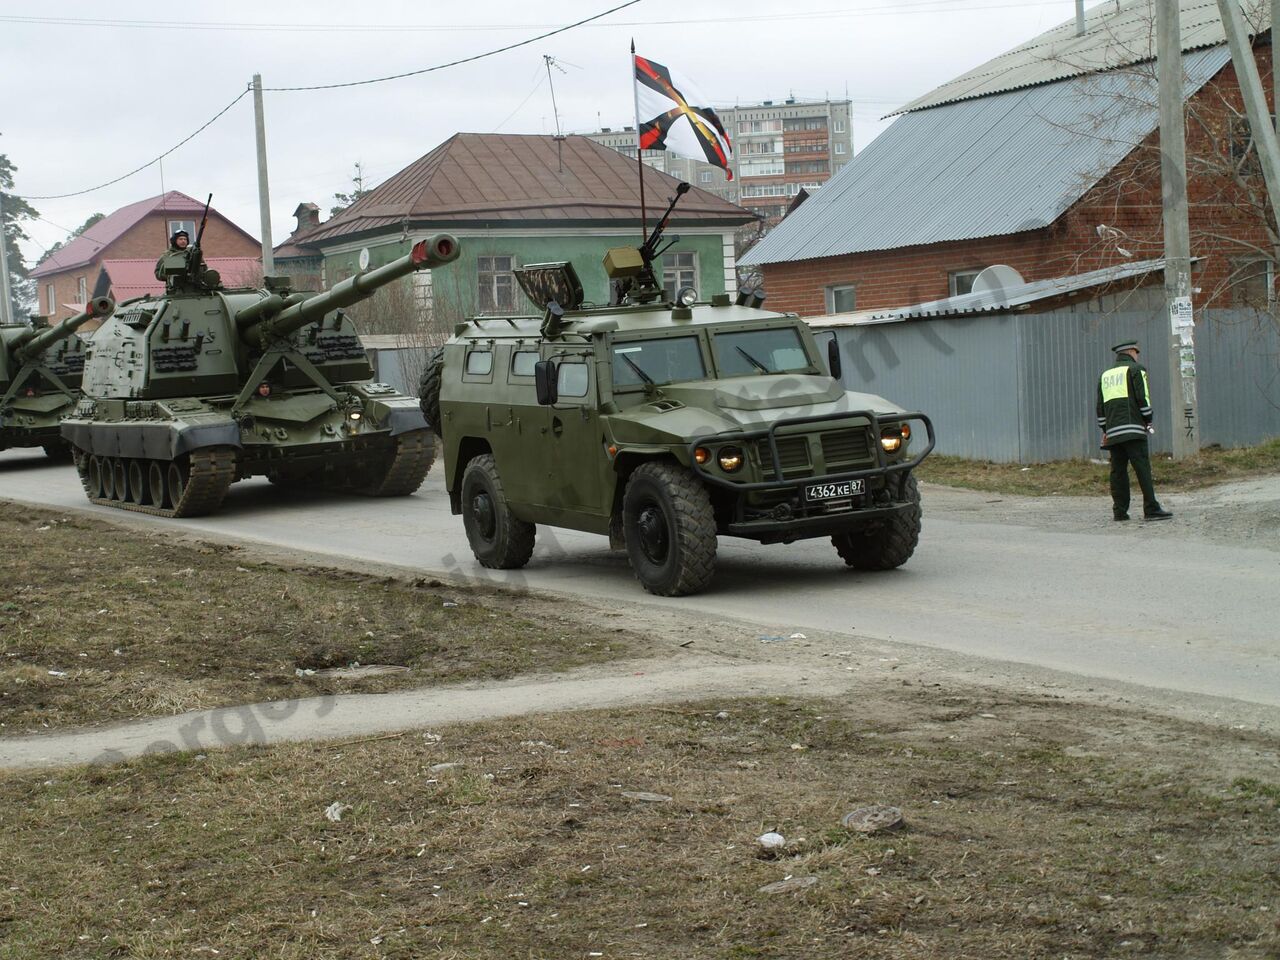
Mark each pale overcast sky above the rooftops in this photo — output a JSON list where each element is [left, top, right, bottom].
[[0, 0, 1093, 264]]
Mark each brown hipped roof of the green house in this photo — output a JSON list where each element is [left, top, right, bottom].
[[291, 133, 756, 244]]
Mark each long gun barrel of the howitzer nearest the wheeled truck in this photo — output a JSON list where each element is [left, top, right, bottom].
[[236, 233, 458, 347]]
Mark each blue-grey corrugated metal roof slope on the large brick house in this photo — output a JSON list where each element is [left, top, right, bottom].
[[739, 46, 1229, 266]]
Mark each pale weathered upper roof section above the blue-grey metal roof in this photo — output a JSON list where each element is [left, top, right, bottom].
[[891, 0, 1271, 115]]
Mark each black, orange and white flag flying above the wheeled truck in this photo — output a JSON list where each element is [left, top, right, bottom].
[[635, 56, 733, 179]]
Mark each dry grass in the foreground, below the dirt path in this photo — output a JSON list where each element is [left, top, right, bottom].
[[0, 687, 1280, 960]]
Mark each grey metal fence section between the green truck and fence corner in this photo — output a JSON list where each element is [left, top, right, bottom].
[[823, 316, 1020, 462]]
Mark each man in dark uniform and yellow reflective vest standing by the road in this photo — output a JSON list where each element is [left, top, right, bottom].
[[1098, 340, 1174, 520]]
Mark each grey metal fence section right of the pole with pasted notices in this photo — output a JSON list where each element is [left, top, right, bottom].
[[1196, 310, 1280, 447]]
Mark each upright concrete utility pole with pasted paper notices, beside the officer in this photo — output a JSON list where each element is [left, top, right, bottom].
[[1156, 0, 1192, 460]]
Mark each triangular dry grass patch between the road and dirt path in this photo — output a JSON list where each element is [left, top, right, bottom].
[[0, 508, 644, 735]]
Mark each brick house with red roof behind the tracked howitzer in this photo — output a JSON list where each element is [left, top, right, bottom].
[[31, 191, 261, 323]]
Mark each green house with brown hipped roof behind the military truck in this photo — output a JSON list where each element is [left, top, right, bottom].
[[275, 133, 756, 333]]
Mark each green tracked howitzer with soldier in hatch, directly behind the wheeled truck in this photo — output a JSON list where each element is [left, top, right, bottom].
[[61, 218, 458, 517]]
